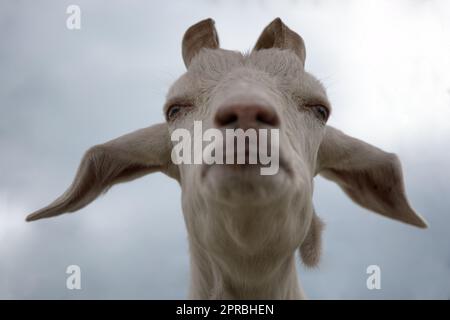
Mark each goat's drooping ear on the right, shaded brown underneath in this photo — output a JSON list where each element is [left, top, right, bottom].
[[316, 126, 427, 228]]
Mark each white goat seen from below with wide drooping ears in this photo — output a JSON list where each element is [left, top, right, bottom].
[[27, 18, 427, 299]]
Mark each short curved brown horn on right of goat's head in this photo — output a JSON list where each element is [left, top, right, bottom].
[[253, 18, 306, 66]]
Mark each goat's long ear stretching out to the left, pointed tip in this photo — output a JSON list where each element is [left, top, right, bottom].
[[26, 124, 176, 221]]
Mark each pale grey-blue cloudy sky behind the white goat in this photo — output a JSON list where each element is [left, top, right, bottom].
[[0, 0, 450, 299]]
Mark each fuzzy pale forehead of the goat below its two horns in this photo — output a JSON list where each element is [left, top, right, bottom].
[[167, 49, 327, 100]]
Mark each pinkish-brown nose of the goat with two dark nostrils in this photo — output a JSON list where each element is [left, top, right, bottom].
[[214, 104, 280, 129]]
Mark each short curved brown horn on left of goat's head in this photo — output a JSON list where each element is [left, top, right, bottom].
[[182, 18, 219, 68]]
